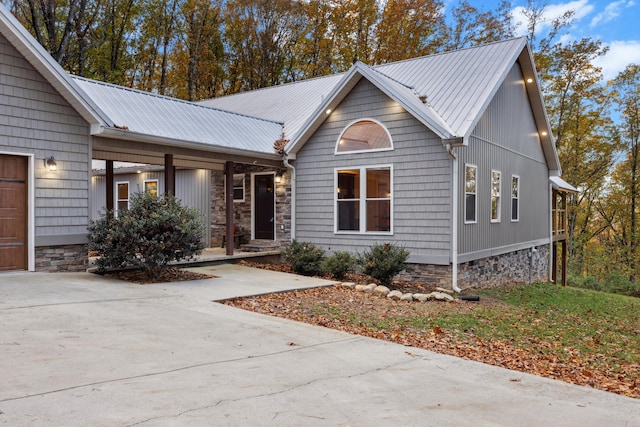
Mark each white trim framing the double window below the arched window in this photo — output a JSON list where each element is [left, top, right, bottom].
[[333, 164, 395, 236]]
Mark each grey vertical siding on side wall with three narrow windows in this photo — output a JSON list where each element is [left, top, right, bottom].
[[457, 63, 550, 262]]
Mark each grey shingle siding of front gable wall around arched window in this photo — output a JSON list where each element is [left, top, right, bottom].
[[295, 79, 451, 265]]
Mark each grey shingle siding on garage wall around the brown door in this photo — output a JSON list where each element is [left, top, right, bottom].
[[0, 31, 91, 246]]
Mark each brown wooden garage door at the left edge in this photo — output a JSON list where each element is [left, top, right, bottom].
[[0, 154, 27, 271]]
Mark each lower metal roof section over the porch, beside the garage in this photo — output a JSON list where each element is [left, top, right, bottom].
[[73, 77, 282, 154]]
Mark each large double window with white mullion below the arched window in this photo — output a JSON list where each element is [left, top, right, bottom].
[[336, 166, 392, 234]]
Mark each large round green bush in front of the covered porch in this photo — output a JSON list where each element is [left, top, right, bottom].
[[89, 193, 205, 279]]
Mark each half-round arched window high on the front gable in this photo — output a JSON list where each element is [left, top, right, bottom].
[[336, 119, 393, 154]]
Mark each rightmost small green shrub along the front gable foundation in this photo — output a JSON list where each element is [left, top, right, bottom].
[[357, 243, 409, 286]]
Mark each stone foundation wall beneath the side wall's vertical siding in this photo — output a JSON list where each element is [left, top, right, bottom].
[[458, 245, 549, 289]]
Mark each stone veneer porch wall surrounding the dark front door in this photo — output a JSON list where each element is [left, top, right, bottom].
[[211, 164, 291, 247]]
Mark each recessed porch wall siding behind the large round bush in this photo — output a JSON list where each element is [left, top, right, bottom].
[[91, 169, 211, 246]]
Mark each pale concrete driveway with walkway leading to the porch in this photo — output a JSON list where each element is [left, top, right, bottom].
[[0, 265, 640, 427]]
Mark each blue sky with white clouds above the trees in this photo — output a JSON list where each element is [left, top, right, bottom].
[[482, 0, 640, 80]]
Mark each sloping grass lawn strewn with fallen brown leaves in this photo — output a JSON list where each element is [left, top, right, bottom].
[[228, 284, 640, 398]]
